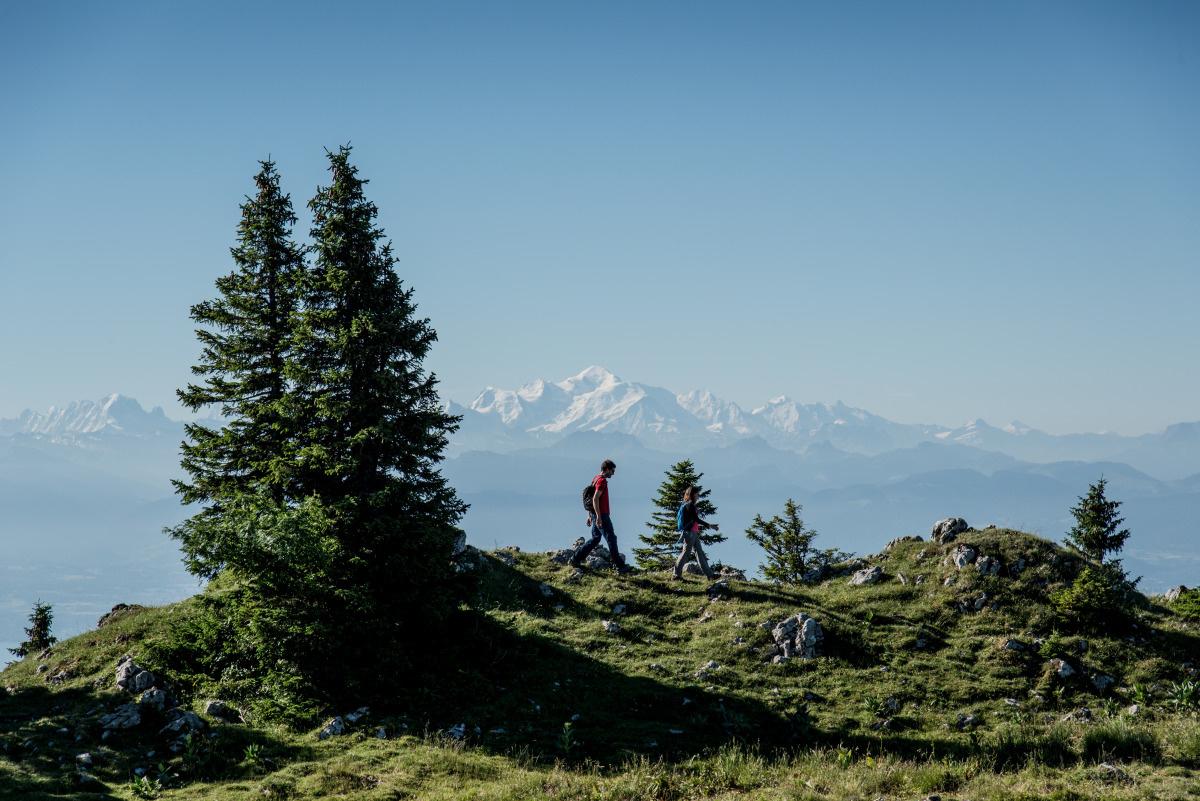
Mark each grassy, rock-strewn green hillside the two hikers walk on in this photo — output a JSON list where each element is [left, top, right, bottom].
[[0, 529, 1200, 799]]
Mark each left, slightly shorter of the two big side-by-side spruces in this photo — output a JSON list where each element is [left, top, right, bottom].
[[169, 161, 304, 577]]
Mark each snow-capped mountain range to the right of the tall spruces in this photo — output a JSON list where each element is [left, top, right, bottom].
[[449, 367, 1200, 478]]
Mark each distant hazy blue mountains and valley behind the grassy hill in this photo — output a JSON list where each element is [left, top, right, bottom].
[[0, 367, 1200, 648]]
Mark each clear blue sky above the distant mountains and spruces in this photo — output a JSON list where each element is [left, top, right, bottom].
[[0, 1, 1200, 433]]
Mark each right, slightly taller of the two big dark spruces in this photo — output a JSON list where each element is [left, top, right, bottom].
[[294, 147, 467, 680]]
